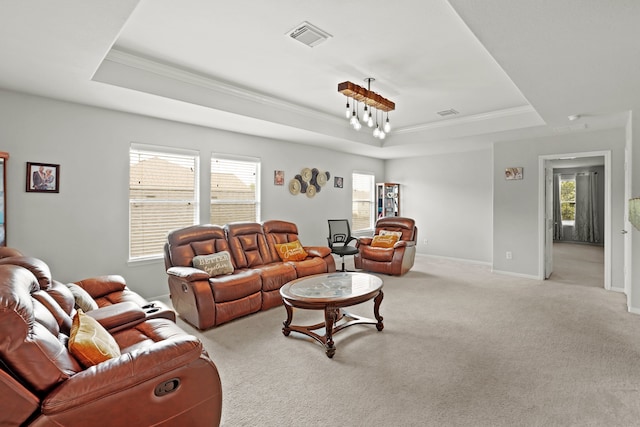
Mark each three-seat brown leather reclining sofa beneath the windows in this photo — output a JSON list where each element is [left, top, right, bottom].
[[164, 220, 336, 329]]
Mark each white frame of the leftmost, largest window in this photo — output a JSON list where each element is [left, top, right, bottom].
[[127, 142, 200, 262]]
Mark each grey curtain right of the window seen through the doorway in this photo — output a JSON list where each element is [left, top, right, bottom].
[[575, 172, 600, 243]]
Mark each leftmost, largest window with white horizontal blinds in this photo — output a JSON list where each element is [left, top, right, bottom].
[[129, 144, 198, 259]]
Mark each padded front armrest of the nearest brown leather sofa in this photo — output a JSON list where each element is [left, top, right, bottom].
[[41, 335, 204, 415]]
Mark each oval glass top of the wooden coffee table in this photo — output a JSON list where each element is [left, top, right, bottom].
[[288, 272, 382, 298]]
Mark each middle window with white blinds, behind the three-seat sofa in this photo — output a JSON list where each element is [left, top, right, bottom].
[[211, 154, 260, 225]]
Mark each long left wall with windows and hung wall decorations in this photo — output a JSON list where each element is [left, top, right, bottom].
[[0, 91, 384, 298]]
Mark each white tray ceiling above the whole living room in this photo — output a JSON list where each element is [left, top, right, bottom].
[[0, 0, 640, 159]]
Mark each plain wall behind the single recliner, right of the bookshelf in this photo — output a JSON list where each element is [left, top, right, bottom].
[[386, 150, 493, 263]]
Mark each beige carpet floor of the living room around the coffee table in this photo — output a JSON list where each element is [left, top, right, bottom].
[[166, 249, 640, 427]]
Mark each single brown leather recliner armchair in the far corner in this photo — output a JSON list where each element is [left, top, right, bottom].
[[354, 217, 418, 276]]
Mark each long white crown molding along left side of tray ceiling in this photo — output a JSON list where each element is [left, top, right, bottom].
[[104, 48, 344, 123]]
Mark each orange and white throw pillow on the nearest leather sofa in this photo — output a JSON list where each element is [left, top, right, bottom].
[[69, 309, 120, 368]]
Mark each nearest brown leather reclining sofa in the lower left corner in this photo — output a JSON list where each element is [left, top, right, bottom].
[[0, 257, 222, 426]]
